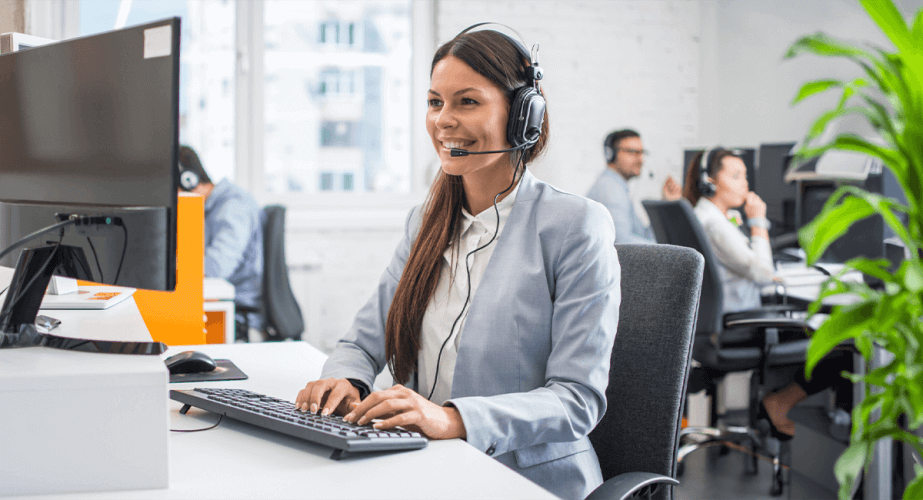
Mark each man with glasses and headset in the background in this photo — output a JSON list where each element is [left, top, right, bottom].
[[587, 129, 682, 243]]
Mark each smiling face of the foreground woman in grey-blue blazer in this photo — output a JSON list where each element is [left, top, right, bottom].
[[426, 55, 510, 175]]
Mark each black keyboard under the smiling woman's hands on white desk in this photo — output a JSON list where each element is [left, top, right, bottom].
[[170, 389, 427, 460]]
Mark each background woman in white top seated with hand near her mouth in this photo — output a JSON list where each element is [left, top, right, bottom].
[[683, 148, 852, 440]]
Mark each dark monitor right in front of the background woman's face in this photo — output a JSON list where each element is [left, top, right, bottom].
[[750, 142, 797, 235]]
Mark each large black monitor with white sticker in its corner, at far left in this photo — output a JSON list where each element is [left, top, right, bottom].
[[0, 18, 180, 348]]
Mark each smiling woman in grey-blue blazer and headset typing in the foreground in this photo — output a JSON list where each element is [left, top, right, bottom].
[[296, 24, 621, 499]]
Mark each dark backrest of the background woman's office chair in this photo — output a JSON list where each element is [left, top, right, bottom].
[[642, 199, 724, 335]]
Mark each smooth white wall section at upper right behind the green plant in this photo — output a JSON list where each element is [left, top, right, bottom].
[[699, 0, 923, 146]]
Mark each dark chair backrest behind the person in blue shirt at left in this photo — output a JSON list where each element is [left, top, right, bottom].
[[261, 205, 304, 340]]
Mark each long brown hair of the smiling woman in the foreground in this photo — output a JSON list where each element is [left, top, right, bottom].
[[385, 30, 548, 383]]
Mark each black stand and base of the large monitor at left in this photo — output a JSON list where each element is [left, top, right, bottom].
[[0, 244, 167, 355]]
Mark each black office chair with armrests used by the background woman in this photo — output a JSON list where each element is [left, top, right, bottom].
[[643, 199, 809, 495]]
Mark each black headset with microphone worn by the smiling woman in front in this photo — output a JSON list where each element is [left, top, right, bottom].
[[451, 22, 545, 156]]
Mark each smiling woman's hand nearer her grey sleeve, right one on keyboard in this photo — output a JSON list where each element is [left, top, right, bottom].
[[342, 385, 467, 439]]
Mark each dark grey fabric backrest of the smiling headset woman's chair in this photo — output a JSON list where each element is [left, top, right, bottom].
[[590, 245, 704, 498]]
